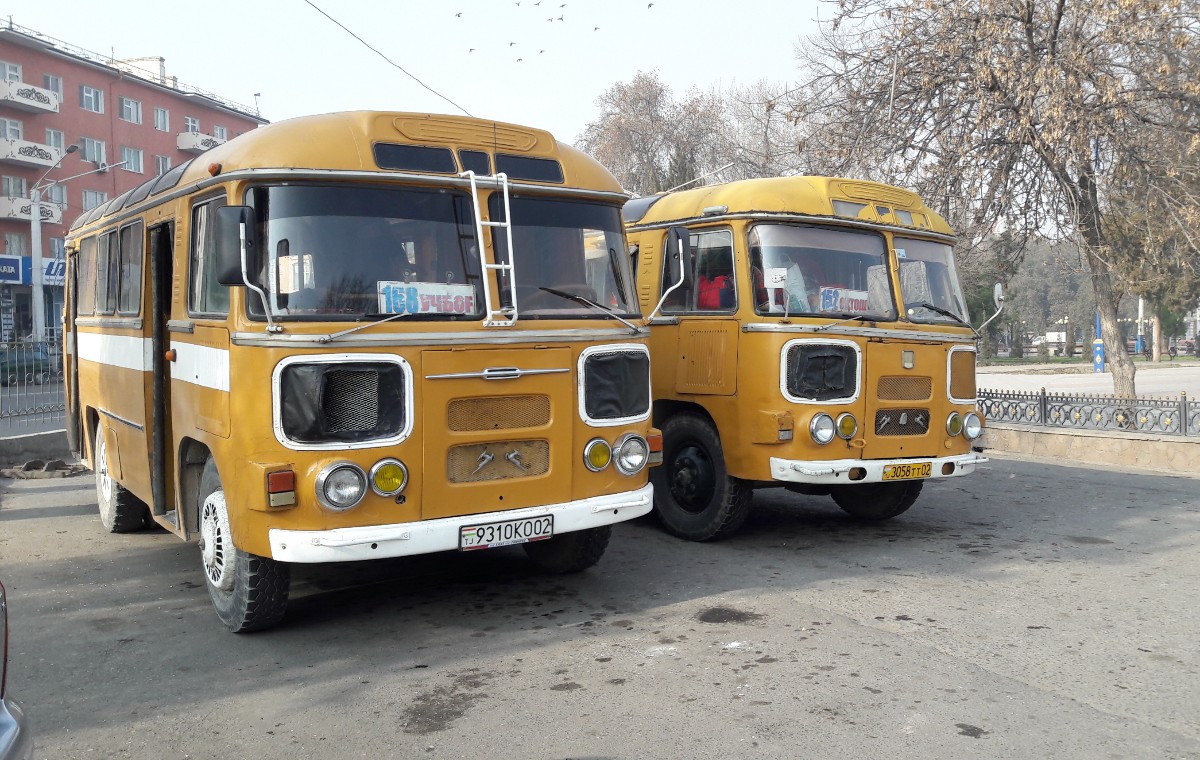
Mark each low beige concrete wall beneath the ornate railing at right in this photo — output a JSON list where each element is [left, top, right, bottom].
[[982, 423, 1200, 475]]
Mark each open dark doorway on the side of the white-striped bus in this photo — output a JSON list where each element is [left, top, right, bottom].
[[146, 222, 180, 532]]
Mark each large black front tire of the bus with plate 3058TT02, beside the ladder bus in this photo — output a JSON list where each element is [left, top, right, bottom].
[[650, 412, 754, 541]]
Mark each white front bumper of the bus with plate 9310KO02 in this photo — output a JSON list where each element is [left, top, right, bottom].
[[269, 483, 654, 562]]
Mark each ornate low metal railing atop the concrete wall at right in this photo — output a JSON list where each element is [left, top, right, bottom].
[[979, 388, 1200, 436]]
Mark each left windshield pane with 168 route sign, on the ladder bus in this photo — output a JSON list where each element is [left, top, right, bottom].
[[250, 185, 484, 321]]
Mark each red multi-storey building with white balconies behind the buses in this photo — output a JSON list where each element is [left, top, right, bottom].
[[0, 22, 266, 340]]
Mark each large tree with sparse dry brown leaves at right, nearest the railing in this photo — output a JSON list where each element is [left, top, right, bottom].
[[792, 0, 1200, 395]]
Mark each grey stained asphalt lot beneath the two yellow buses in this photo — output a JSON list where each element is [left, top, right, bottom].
[[0, 459, 1200, 760]]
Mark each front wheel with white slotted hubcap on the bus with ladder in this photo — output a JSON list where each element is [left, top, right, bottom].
[[196, 459, 292, 633]]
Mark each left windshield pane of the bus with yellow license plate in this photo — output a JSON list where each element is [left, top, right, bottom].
[[750, 225, 896, 321]]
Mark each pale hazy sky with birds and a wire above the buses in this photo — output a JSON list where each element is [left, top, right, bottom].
[[0, 0, 830, 142]]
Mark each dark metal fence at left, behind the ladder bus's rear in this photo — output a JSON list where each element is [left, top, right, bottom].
[[0, 341, 66, 436]]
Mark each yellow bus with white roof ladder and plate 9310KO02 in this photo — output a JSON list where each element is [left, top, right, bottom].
[[65, 112, 661, 632]]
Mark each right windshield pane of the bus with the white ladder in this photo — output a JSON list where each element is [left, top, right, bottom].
[[490, 196, 640, 319]]
